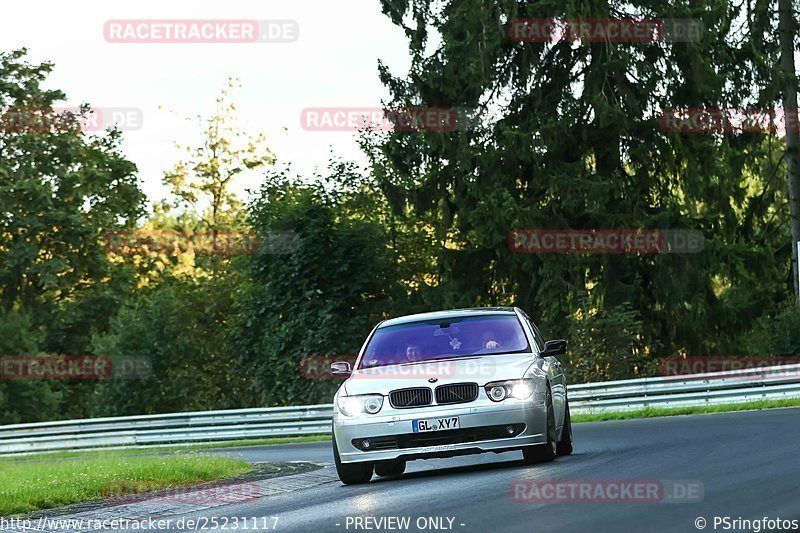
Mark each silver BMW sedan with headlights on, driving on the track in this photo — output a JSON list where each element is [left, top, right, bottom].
[[331, 307, 572, 484]]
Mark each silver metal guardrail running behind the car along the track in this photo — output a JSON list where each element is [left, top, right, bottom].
[[0, 364, 800, 455]]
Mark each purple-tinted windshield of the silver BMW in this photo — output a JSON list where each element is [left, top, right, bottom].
[[359, 314, 530, 368]]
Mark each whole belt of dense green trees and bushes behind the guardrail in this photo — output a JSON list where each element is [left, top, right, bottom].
[[0, 0, 800, 423]]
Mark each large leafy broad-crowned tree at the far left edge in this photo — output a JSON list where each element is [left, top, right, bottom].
[[0, 49, 144, 353]]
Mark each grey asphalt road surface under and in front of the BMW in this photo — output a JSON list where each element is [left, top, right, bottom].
[[12, 409, 800, 533]]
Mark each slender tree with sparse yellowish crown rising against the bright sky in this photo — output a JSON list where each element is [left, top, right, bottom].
[[93, 79, 275, 415]]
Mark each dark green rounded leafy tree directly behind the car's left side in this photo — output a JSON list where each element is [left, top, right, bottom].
[[230, 167, 401, 405]]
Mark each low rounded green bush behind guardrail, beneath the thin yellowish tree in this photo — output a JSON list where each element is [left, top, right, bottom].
[[90, 272, 249, 416]]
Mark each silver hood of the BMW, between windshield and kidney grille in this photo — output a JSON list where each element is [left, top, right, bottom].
[[344, 354, 534, 395]]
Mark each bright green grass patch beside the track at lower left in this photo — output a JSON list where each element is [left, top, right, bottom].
[[0, 450, 253, 516]]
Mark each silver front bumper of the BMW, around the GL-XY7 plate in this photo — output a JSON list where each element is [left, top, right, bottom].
[[333, 394, 547, 463]]
